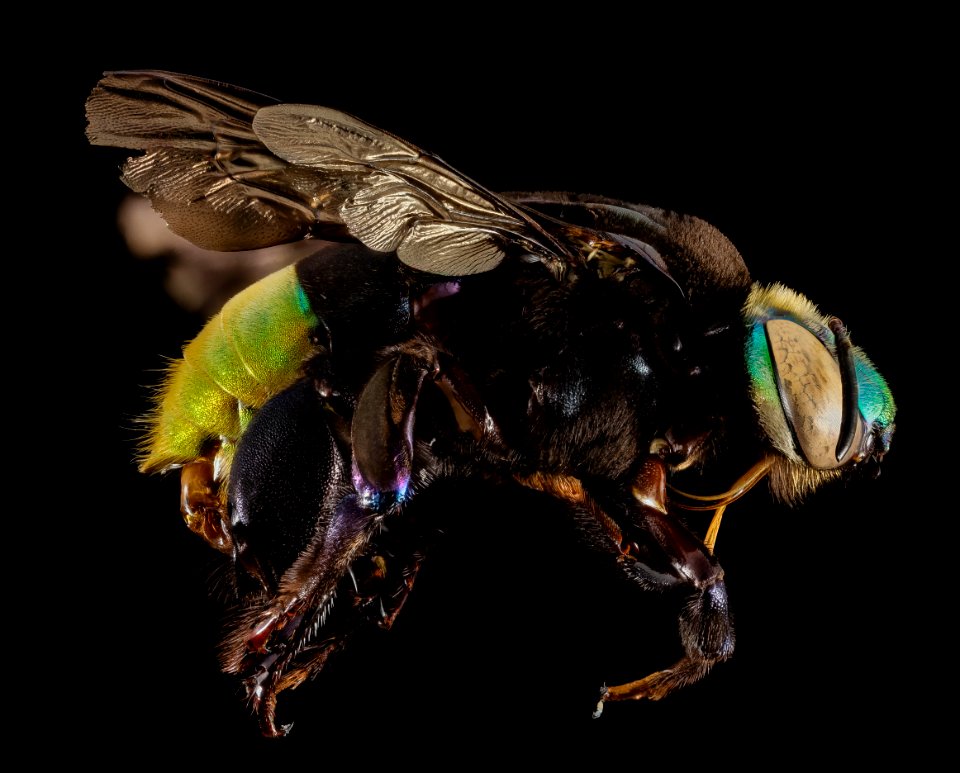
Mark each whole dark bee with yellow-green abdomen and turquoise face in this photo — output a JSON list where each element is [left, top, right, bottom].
[[87, 71, 896, 736]]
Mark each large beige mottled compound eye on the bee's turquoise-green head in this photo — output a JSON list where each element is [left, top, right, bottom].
[[766, 319, 863, 470]]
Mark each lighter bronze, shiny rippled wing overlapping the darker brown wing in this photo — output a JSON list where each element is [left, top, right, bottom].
[[254, 104, 564, 275]]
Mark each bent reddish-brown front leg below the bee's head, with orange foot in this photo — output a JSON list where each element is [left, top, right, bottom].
[[594, 458, 734, 716]]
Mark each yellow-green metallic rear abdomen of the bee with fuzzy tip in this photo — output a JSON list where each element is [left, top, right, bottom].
[[140, 266, 316, 472]]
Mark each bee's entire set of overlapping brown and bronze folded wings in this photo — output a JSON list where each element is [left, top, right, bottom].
[[87, 71, 568, 275]]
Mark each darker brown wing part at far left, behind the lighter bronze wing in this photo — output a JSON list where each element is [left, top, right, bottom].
[[87, 71, 341, 250]]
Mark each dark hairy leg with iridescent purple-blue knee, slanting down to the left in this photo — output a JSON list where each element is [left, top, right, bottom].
[[222, 344, 437, 736]]
